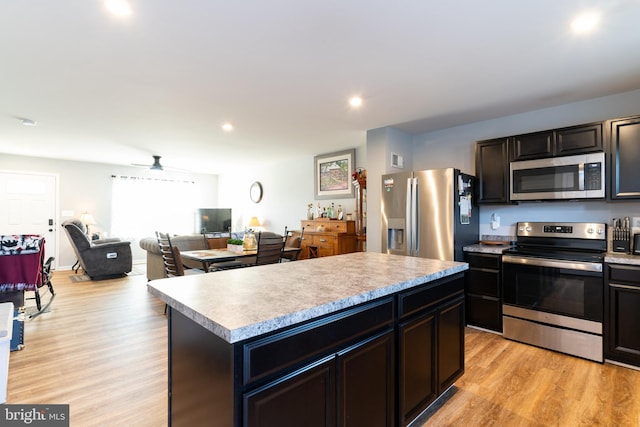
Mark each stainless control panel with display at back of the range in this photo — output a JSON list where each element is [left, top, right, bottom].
[[516, 222, 607, 240]]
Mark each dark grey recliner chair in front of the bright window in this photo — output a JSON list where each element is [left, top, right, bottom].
[[62, 219, 132, 280]]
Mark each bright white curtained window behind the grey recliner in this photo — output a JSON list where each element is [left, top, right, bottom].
[[111, 175, 197, 241]]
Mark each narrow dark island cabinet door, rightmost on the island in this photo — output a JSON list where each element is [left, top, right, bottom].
[[438, 295, 464, 392]]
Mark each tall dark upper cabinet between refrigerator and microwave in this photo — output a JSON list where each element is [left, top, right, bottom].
[[476, 138, 509, 204]]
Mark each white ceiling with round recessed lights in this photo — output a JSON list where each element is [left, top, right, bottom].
[[0, 0, 640, 173]]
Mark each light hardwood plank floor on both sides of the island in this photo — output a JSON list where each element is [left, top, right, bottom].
[[7, 272, 640, 427]]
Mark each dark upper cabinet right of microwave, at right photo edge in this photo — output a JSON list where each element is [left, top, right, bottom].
[[607, 116, 640, 200]]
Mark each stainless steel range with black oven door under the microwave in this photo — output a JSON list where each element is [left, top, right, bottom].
[[502, 222, 607, 362]]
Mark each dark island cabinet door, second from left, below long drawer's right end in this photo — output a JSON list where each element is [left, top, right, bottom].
[[338, 330, 395, 427]]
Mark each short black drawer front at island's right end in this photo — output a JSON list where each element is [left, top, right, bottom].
[[398, 273, 464, 318]]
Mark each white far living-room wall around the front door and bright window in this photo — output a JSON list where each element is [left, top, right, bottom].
[[0, 154, 218, 269]]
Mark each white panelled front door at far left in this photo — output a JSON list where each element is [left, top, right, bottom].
[[0, 172, 58, 265]]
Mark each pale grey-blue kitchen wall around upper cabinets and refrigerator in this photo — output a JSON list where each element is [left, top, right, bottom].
[[367, 90, 640, 252]]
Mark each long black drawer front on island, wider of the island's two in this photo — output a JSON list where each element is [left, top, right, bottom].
[[243, 298, 394, 384]]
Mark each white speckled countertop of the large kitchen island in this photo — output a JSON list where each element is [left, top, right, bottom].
[[147, 252, 468, 343]]
